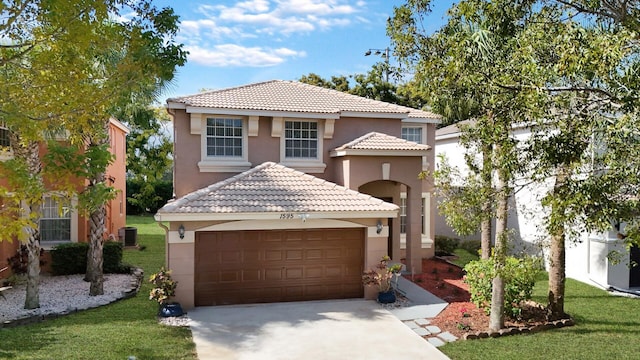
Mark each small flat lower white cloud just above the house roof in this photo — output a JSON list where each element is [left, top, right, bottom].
[[187, 44, 306, 67]]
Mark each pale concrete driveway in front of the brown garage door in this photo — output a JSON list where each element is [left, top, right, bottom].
[[188, 299, 448, 360]]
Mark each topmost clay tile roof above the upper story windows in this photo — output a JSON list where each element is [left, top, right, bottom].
[[167, 80, 440, 121]]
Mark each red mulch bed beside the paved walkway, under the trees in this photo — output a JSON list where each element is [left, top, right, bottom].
[[405, 258, 546, 338]]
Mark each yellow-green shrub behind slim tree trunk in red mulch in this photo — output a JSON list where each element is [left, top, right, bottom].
[[464, 257, 540, 318]]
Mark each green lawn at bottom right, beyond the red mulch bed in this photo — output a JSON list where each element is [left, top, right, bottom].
[[440, 272, 640, 360]]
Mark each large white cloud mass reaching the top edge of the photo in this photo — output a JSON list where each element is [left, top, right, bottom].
[[179, 0, 367, 67]]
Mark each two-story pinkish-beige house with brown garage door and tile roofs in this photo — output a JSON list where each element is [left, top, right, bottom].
[[156, 81, 440, 308]]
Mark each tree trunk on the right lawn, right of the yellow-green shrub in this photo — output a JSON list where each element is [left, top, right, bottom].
[[547, 165, 569, 319]]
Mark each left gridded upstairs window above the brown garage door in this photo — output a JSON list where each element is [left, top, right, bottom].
[[206, 118, 244, 157]]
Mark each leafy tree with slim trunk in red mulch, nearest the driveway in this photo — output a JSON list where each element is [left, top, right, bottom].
[[387, 0, 526, 330]]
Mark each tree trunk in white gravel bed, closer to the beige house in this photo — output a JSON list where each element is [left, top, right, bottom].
[[85, 120, 110, 296]]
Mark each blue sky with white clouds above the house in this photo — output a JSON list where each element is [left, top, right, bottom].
[[155, 0, 453, 100]]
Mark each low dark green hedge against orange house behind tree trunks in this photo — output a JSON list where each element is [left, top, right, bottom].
[[51, 241, 131, 275]]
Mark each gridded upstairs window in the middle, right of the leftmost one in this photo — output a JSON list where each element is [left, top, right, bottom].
[[284, 121, 318, 159]]
